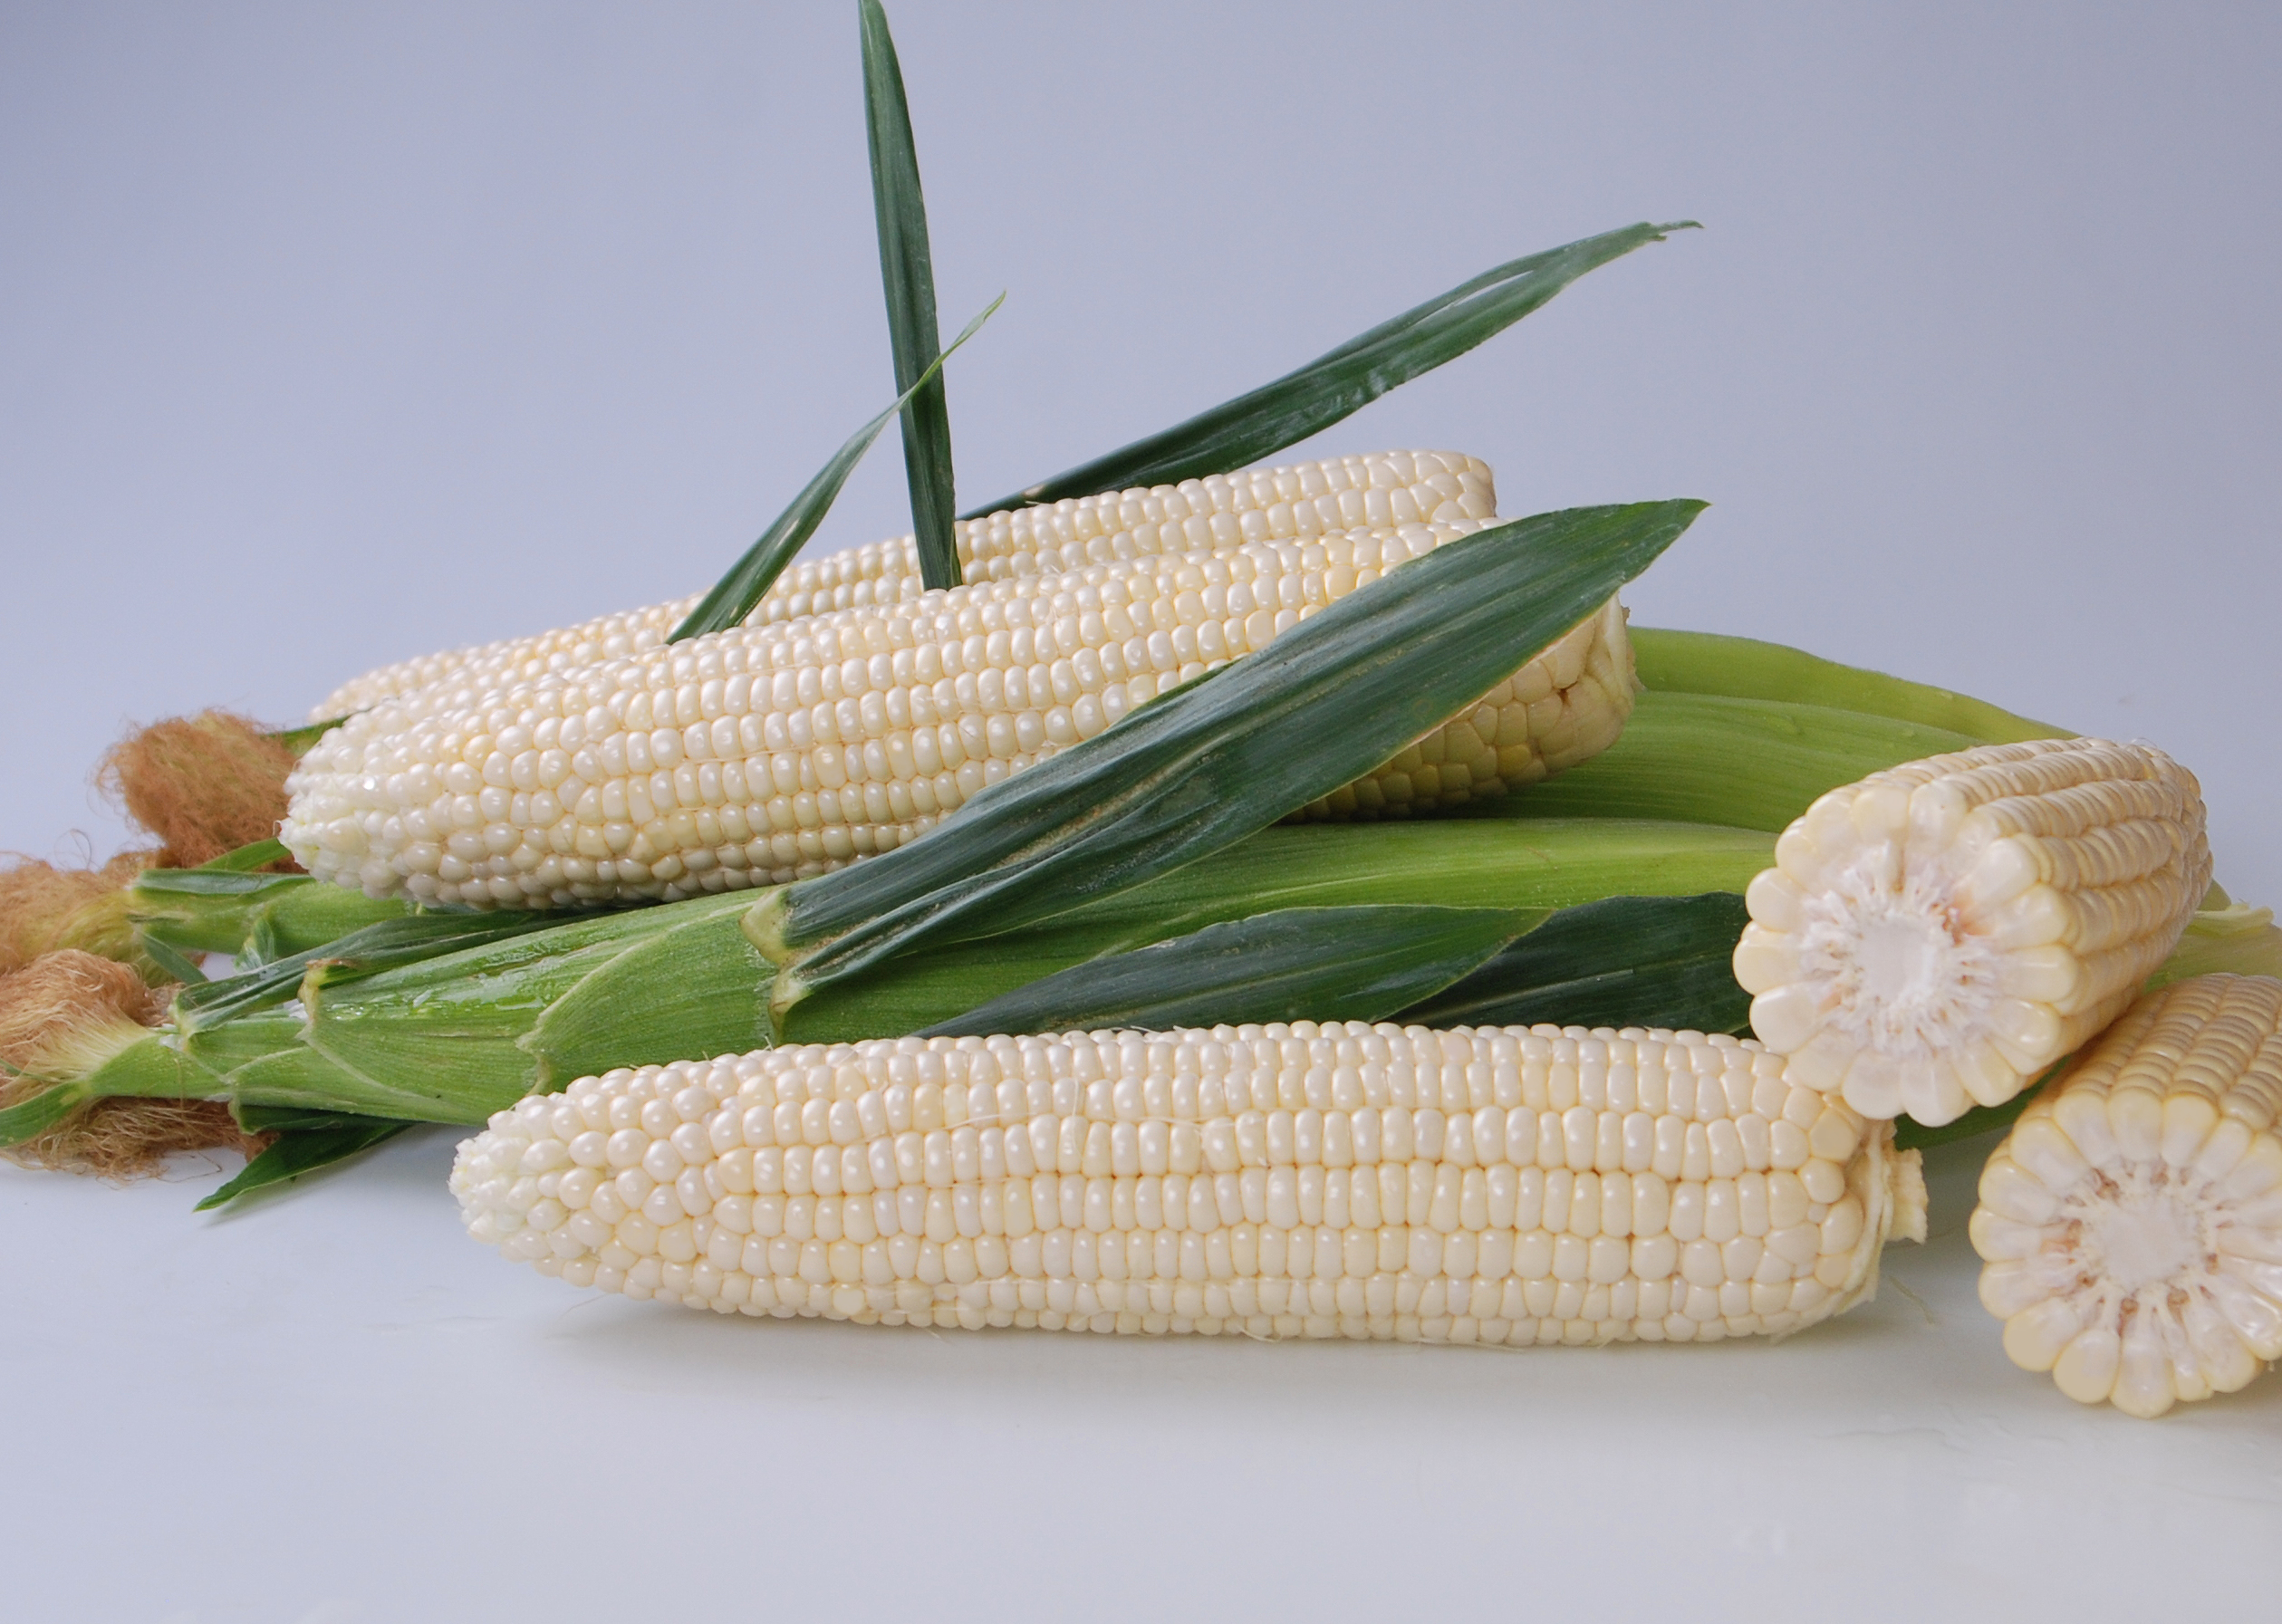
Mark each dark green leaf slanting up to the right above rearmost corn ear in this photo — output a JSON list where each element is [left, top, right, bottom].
[[966, 221, 1696, 518]]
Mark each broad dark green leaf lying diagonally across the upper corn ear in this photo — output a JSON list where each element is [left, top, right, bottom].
[[746, 502, 1702, 1011]]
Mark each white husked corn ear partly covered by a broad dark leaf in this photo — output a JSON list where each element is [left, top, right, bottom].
[[281, 520, 1632, 908]]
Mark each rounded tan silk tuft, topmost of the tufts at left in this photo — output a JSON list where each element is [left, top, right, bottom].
[[98, 712, 294, 869]]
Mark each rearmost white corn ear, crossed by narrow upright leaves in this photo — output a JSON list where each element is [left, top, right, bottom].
[[311, 452, 1497, 721]]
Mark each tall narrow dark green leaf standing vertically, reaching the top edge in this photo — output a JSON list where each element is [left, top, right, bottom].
[[856, 0, 960, 591]]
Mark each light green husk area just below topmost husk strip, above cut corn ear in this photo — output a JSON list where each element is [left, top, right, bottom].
[[1468, 689, 1979, 832]]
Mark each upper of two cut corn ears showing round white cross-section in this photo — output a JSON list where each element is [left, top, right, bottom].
[[1734, 739, 2211, 1125]]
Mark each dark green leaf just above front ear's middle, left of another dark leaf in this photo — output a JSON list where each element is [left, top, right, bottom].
[[920, 903, 1545, 1038]]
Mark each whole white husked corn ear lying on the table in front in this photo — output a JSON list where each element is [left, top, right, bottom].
[[452, 1022, 1924, 1346]]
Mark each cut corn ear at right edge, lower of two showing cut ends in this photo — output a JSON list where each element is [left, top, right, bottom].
[[1971, 976, 2282, 1417]]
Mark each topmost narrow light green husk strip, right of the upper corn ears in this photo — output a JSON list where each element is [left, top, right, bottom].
[[1632, 625, 2075, 744]]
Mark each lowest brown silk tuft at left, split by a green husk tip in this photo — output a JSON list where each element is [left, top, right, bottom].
[[0, 947, 265, 1179]]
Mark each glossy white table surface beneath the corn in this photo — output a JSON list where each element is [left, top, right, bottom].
[[0, 1131, 2282, 1624]]
